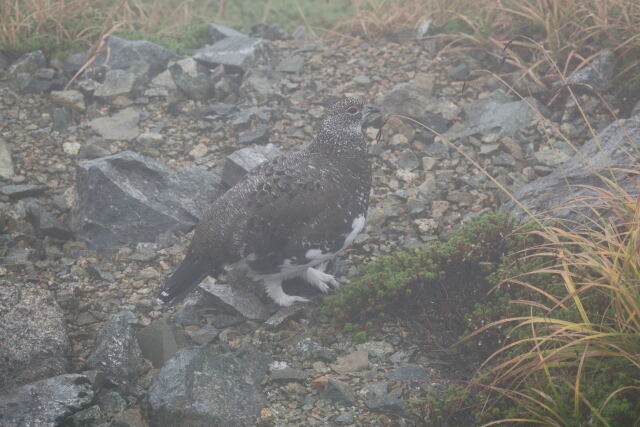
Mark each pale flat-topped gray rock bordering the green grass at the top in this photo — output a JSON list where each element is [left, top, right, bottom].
[[193, 37, 272, 72]]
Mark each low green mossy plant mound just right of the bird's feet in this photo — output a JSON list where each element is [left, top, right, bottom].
[[324, 214, 513, 326]]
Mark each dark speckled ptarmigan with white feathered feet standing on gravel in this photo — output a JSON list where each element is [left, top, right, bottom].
[[158, 98, 380, 306]]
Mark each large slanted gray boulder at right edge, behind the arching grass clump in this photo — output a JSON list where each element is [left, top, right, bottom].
[[500, 116, 640, 223]]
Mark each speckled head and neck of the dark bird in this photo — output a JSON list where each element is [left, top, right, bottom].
[[316, 98, 380, 151]]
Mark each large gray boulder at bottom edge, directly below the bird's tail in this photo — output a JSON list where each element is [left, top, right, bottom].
[[148, 346, 271, 426]]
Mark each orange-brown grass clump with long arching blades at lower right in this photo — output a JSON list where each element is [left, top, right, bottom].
[[473, 180, 640, 425]]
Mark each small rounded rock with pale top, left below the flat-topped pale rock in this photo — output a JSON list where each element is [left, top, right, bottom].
[[169, 58, 222, 101]]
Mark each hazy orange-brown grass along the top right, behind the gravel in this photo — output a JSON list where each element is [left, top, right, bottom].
[[331, 0, 640, 89]]
